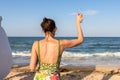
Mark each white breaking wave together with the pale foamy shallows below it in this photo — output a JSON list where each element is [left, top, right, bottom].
[[12, 51, 120, 66]]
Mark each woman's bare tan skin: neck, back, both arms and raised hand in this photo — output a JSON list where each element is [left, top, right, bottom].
[[30, 13, 83, 71]]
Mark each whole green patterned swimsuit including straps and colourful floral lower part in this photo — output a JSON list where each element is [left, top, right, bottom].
[[34, 41, 61, 80]]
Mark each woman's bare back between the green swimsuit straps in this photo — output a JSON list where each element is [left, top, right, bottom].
[[39, 39, 59, 64]]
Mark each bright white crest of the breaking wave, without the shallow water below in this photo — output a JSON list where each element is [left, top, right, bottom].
[[12, 51, 120, 58]]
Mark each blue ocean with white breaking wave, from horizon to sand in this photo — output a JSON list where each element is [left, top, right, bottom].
[[8, 37, 120, 66]]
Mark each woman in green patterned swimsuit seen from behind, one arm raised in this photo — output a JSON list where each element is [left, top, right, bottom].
[[30, 13, 83, 80]]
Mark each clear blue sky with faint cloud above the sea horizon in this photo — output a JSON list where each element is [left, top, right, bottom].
[[0, 0, 120, 37]]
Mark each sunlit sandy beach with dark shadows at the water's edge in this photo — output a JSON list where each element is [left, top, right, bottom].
[[4, 65, 120, 80]]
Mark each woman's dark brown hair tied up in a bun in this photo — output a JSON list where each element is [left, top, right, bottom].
[[41, 17, 56, 33]]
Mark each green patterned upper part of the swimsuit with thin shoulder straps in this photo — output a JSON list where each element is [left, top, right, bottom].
[[38, 40, 61, 72]]
